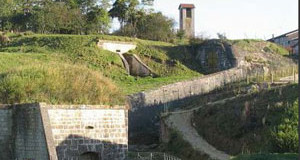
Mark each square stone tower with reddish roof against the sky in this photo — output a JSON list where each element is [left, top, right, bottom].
[[178, 4, 195, 37]]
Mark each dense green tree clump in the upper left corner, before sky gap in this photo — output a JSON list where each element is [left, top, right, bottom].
[[0, 0, 110, 34]]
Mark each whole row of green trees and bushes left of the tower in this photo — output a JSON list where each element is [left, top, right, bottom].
[[0, 0, 175, 41]]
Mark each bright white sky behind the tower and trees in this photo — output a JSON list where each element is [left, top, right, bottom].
[[113, 0, 298, 40]]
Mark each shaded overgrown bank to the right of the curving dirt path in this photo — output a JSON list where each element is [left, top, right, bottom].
[[193, 85, 298, 155]]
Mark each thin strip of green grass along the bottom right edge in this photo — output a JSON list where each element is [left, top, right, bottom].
[[231, 153, 298, 160]]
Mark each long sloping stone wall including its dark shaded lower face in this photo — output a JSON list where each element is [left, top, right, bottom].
[[128, 68, 247, 144]]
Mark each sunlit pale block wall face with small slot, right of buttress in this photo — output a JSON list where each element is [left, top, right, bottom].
[[48, 105, 128, 160]]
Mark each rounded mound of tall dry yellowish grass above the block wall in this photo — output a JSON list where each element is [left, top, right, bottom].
[[0, 63, 125, 105]]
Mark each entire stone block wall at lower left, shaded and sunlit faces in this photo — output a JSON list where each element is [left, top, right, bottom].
[[0, 103, 128, 160]]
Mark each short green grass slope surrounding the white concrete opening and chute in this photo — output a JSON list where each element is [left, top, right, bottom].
[[0, 34, 202, 94]]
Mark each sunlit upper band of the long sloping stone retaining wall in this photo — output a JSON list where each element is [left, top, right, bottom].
[[128, 68, 247, 109]]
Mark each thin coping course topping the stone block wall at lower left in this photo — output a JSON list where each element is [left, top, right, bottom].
[[0, 103, 129, 110]]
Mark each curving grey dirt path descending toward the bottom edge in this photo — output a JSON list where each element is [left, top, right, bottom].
[[166, 112, 230, 160]]
